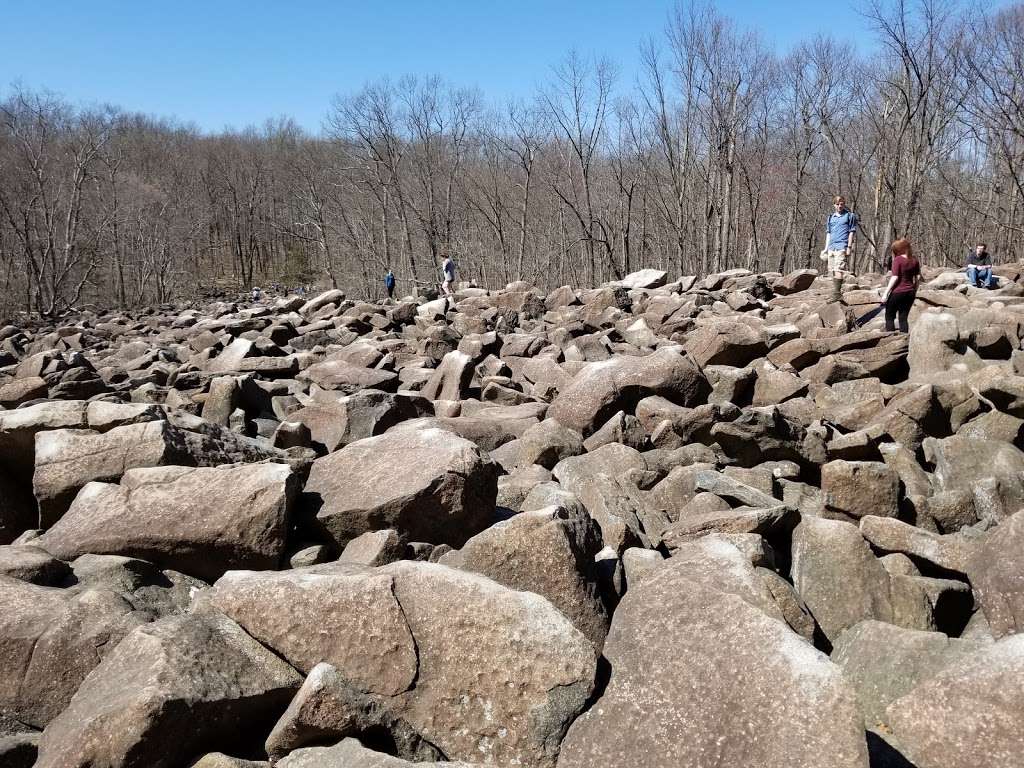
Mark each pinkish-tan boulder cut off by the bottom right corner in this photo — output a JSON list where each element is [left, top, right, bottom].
[[886, 635, 1024, 768]]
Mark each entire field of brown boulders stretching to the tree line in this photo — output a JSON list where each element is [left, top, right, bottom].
[[0, 266, 1024, 768]]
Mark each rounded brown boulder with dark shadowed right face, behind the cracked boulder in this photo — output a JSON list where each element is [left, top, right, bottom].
[[304, 427, 498, 547]]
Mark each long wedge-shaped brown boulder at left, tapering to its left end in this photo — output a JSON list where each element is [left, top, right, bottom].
[[34, 464, 299, 581]]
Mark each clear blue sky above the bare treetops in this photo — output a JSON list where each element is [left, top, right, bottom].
[[0, 0, 872, 131]]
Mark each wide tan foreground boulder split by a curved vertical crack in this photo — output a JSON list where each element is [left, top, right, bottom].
[[214, 561, 596, 768]]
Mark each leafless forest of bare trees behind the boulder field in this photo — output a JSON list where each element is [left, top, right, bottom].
[[0, 0, 1024, 317]]
